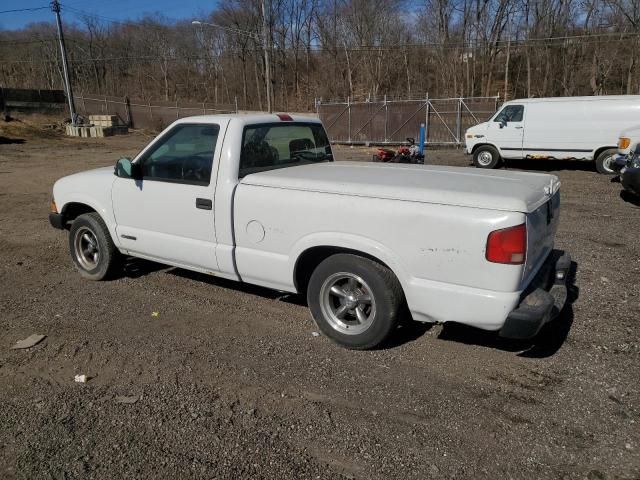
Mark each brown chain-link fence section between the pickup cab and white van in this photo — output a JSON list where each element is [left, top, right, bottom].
[[315, 97, 500, 145]]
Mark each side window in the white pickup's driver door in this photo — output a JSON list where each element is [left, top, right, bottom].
[[139, 124, 220, 185]]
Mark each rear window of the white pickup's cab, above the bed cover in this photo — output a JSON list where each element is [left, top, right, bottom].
[[238, 122, 333, 178]]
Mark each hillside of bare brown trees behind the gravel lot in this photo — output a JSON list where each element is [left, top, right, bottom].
[[0, 0, 640, 110]]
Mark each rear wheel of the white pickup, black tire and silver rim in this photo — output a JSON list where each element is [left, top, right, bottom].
[[307, 253, 405, 350]]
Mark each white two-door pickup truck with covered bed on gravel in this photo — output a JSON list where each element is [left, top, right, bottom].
[[49, 114, 570, 349]]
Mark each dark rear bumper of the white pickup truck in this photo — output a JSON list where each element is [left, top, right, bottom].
[[500, 250, 571, 339]]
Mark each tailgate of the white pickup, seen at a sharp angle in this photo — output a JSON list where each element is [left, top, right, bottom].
[[522, 190, 560, 288]]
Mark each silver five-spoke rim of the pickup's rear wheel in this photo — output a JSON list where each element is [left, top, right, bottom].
[[320, 272, 376, 335]]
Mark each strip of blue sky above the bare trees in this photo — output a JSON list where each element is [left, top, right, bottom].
[[0, 0, 217, 30]]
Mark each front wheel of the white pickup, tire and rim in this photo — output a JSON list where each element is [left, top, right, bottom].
[[69, 212, 121, 280]]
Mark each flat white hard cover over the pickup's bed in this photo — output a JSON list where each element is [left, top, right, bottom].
[[242, 162, 560, 213]]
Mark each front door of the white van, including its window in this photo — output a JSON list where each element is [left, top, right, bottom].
[[487, 104, 525, 158]]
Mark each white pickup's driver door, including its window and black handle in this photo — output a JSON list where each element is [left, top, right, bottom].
[[112, 123, 220, 271]]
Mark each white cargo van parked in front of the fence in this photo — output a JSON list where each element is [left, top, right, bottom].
[[465, 95, 640, 174]]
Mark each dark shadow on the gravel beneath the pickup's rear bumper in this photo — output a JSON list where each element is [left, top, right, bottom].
[[438, 262, 580, 358]]
